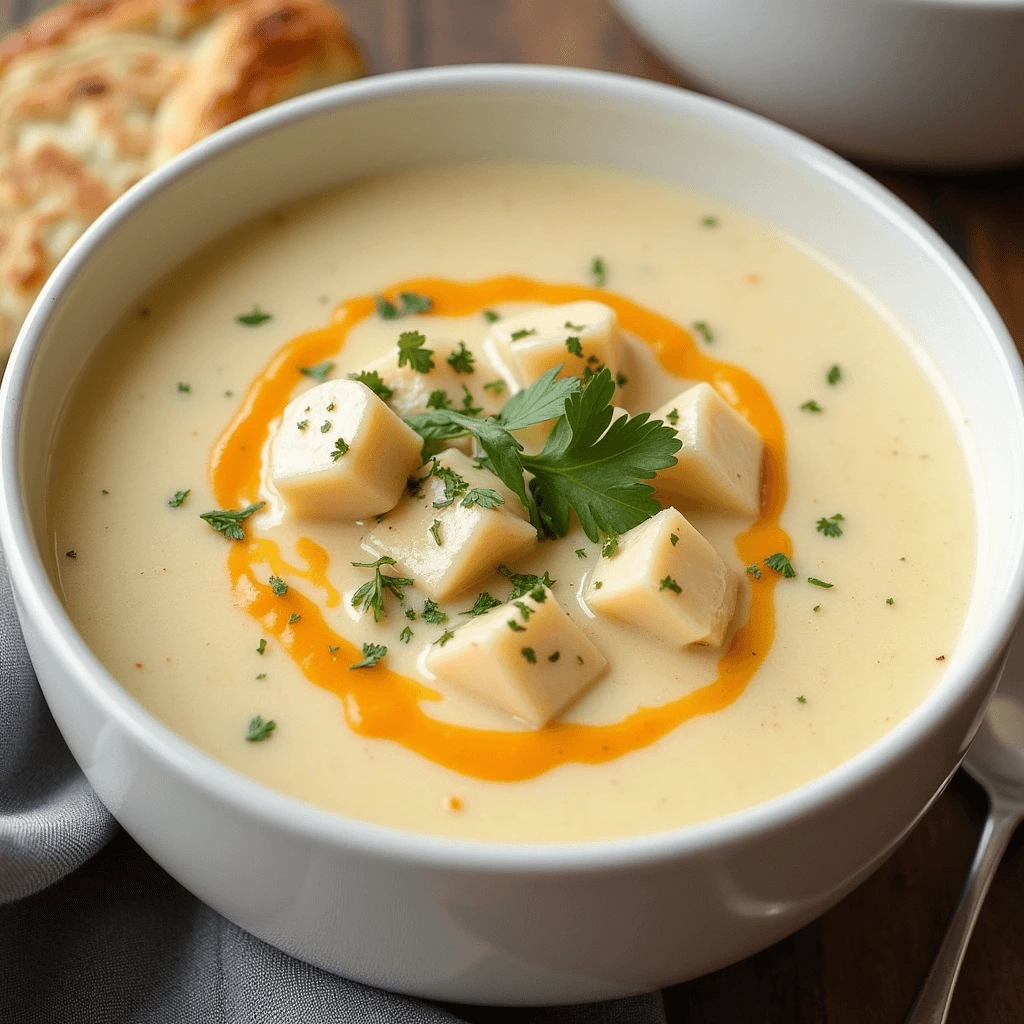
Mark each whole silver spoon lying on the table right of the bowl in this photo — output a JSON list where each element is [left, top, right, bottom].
[[903, 630, 1024, 1024]]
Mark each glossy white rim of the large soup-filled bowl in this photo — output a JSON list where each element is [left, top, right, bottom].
[[0, 65, 1024, 873]]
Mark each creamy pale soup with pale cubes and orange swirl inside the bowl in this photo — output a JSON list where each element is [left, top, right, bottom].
[[50, 164, 975, 842]]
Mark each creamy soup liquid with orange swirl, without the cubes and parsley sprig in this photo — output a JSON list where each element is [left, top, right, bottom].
[[50, 164, 975, 842]]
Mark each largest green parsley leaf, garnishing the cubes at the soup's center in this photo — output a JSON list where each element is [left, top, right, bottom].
[[524, 369, 682, 542]]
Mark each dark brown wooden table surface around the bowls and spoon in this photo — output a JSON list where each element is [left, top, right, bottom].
[[6, 0, 1024, 1024]]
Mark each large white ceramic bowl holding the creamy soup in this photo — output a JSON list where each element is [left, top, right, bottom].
[[0, 67, 1024, 1004]]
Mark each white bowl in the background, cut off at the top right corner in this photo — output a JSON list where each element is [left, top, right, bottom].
[[612, 0, 1024, 169]]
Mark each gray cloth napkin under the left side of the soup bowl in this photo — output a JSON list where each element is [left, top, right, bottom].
[[0, 554, 665, 1024]]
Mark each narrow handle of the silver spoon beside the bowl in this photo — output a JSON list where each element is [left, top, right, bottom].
[[903, 800, 1020, 1024]]
